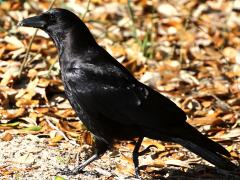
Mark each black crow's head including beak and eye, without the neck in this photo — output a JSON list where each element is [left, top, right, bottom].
[[18, 8, 80, 34]]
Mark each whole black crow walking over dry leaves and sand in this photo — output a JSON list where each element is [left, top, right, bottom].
[[19, 8, 238, 177]]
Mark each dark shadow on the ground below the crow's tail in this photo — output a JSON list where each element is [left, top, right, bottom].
[[141, 164, 240, 180]]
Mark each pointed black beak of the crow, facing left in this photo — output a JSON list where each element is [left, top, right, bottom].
[[18, 16, 47, 29]]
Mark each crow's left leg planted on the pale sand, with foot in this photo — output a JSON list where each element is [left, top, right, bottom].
[[60, 139, 108, 175]]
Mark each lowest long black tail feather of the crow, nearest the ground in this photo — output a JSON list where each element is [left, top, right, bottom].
[[172, 138, 239, 171]]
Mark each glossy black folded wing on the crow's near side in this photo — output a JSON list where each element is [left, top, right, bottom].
[[63, 50, 186, 129]]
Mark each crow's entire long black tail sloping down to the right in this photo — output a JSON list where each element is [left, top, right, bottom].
[[144, 123, 239, 171]]
